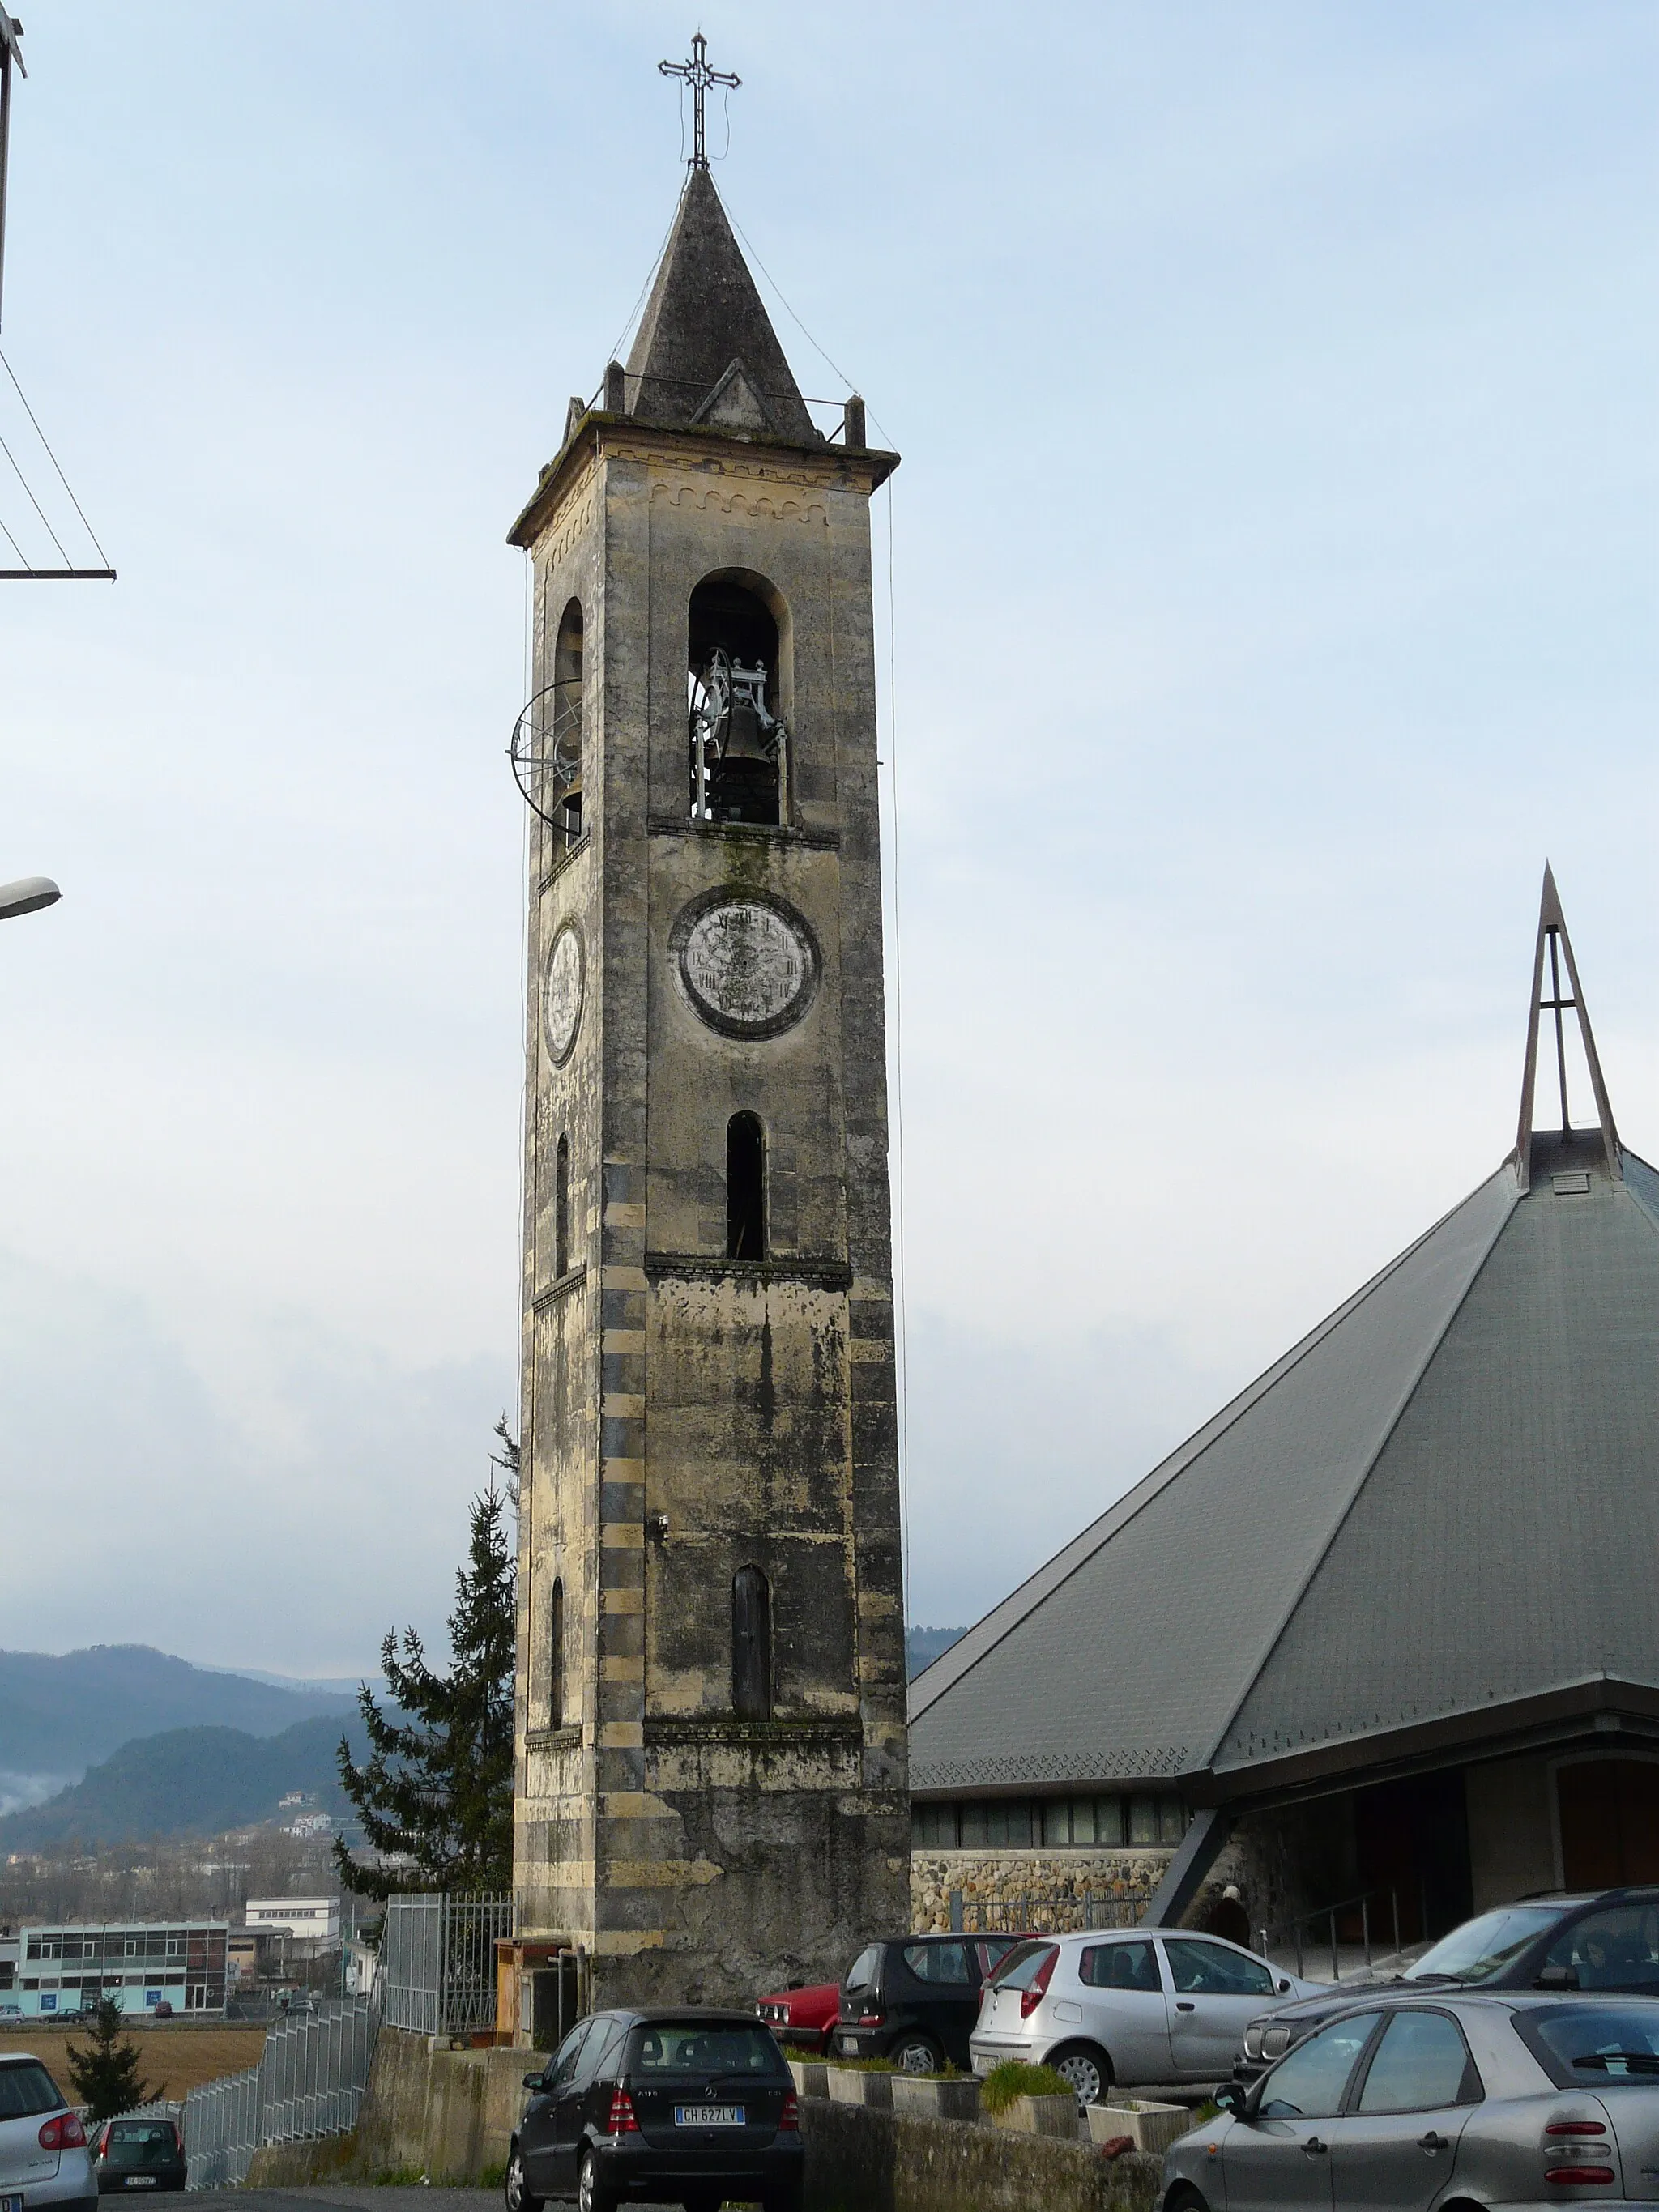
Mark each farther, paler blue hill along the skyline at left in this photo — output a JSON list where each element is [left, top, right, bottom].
[[0, 1643, 356, 1812]]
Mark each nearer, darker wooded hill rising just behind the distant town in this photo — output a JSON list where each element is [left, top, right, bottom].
[[0, 1716, 363, 1858]]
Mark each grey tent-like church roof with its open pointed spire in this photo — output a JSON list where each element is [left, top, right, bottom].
[[911, 876, 1659, 1792]]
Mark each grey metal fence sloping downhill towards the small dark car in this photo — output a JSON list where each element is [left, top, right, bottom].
[[184, 1997, 381, 2190]]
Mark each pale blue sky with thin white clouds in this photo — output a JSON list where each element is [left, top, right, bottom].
[[0, 0, 1659, 1677]]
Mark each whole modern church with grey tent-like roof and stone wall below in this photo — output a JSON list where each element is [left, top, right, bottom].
[[909, 872, 1659, 1942]]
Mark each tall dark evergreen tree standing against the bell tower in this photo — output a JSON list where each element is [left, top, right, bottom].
[[334, 1468, 518, 1900]]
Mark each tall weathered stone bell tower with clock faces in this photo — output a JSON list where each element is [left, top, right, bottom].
[[511, 134, 909, 2004]]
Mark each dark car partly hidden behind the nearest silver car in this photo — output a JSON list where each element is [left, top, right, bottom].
[[1232, 1887, 1659, 2086]]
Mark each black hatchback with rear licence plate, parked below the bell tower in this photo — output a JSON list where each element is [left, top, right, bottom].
[[506, 2006, 801, 2212]]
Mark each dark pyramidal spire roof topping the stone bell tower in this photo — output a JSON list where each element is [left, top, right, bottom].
[[624, 168, 821, 445]]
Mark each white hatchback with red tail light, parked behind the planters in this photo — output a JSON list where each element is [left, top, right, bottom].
[[969, 1929, 1325, 2103]]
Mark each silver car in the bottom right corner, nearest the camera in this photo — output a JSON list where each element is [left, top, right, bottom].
[[1163, 1991, 1659, 2212]]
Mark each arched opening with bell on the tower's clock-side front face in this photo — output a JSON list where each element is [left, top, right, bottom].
[[686, 571, 790, 827]]
